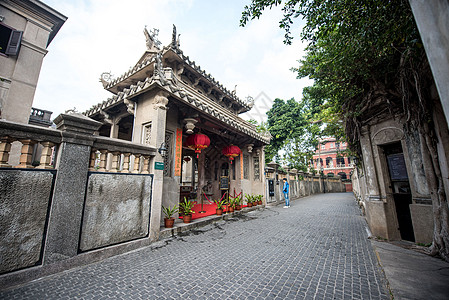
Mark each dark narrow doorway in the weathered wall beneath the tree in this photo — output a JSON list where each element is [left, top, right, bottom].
[[383, 142, 415, 242]]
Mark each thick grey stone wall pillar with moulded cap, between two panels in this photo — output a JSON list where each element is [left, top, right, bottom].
[[43, 114, 101, 264]]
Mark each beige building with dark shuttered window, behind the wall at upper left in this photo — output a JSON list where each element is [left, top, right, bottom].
[[0, 0, 67, 123]]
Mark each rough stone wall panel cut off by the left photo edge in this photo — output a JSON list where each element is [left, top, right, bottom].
[[0, 169, 56, 274]]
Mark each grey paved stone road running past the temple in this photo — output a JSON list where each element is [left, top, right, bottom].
[[0, 193, 388, 299]]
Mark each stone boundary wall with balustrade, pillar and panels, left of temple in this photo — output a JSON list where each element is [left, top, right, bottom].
[[0, 114, 160, 287]]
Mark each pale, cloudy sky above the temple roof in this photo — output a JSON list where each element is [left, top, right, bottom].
[[33, 0, 312, 122]]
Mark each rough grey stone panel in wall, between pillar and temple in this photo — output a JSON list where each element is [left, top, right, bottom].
[[80, 172, 152, 251]]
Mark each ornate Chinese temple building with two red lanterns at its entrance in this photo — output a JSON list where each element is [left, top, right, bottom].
[[83, 26, 270, 223]]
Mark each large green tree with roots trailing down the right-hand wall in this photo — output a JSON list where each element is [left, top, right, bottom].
[[241, 0, 449, 261]]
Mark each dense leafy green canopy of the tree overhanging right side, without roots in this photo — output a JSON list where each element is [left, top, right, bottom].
[[241, 0, 430, 155]]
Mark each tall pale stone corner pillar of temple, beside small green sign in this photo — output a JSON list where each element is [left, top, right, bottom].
[[150, 91, 168, 241]]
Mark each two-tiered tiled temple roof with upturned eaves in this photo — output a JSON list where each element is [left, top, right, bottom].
[[84, 27, 271, 144]]
